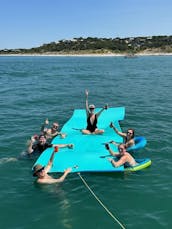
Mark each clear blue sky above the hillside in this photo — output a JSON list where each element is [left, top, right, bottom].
[[0, 0, 172, 49]]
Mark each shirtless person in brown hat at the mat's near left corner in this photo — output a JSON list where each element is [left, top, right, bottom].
[[33, 147, 71, 184]]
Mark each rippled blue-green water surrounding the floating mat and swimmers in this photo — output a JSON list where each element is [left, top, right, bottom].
[[0, 56, 172, 229]]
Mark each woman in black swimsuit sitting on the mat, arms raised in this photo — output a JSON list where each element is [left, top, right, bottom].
[[82, 90, 108, 134]]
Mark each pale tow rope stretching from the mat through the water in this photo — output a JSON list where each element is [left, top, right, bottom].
[[77, 173, 125, 229]]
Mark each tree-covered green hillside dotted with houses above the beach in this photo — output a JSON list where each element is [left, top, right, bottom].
[[0, 36, 172, 54]]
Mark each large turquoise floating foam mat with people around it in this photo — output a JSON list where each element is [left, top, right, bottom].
[[35, 107, 125, 172]]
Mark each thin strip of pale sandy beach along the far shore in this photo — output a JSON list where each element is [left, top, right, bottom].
[[0, 52, 172, 58]]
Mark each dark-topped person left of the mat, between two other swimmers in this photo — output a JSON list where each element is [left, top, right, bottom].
[[27, 135, 73, 155]]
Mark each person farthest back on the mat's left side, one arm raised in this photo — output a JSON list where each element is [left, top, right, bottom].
[[41, 118, 66, 140]]
